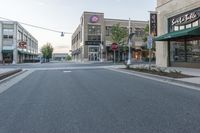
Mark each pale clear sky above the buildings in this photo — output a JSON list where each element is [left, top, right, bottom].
[[0, 0, 156, 53]]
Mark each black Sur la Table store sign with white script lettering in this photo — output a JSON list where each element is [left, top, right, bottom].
[[171, 9, 200, 26]]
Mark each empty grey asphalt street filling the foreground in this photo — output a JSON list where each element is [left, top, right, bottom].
[[0, 63, 200, 133]]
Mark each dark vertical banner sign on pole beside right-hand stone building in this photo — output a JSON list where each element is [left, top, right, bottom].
[[150, 13, 157, 36]]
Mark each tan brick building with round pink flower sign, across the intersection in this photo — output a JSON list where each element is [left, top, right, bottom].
[[71, 12, 148, 61]]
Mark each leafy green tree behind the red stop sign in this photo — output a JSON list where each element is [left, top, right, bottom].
[[111, 23, 128, 61]]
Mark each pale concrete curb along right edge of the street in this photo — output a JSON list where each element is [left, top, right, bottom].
[[110, 68, 200, 90]]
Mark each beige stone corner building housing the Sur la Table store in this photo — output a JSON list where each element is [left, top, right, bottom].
[[156, 0, 200, 68]]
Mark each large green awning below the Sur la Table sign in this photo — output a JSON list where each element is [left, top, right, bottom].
[[155, 26, 200, 41]]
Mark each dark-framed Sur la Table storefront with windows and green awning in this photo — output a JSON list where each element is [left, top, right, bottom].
[[156, 8, 200, 68]]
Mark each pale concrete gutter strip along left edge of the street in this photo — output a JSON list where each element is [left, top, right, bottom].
[[0, 70, 34, 94]]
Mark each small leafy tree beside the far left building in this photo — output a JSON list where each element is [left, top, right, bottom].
[[41, 43, 53, 61]]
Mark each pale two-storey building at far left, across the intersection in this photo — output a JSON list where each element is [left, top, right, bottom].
[[0, 21, 38, 64]]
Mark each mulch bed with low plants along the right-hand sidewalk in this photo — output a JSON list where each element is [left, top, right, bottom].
[[125, 68, 195, 78]]
